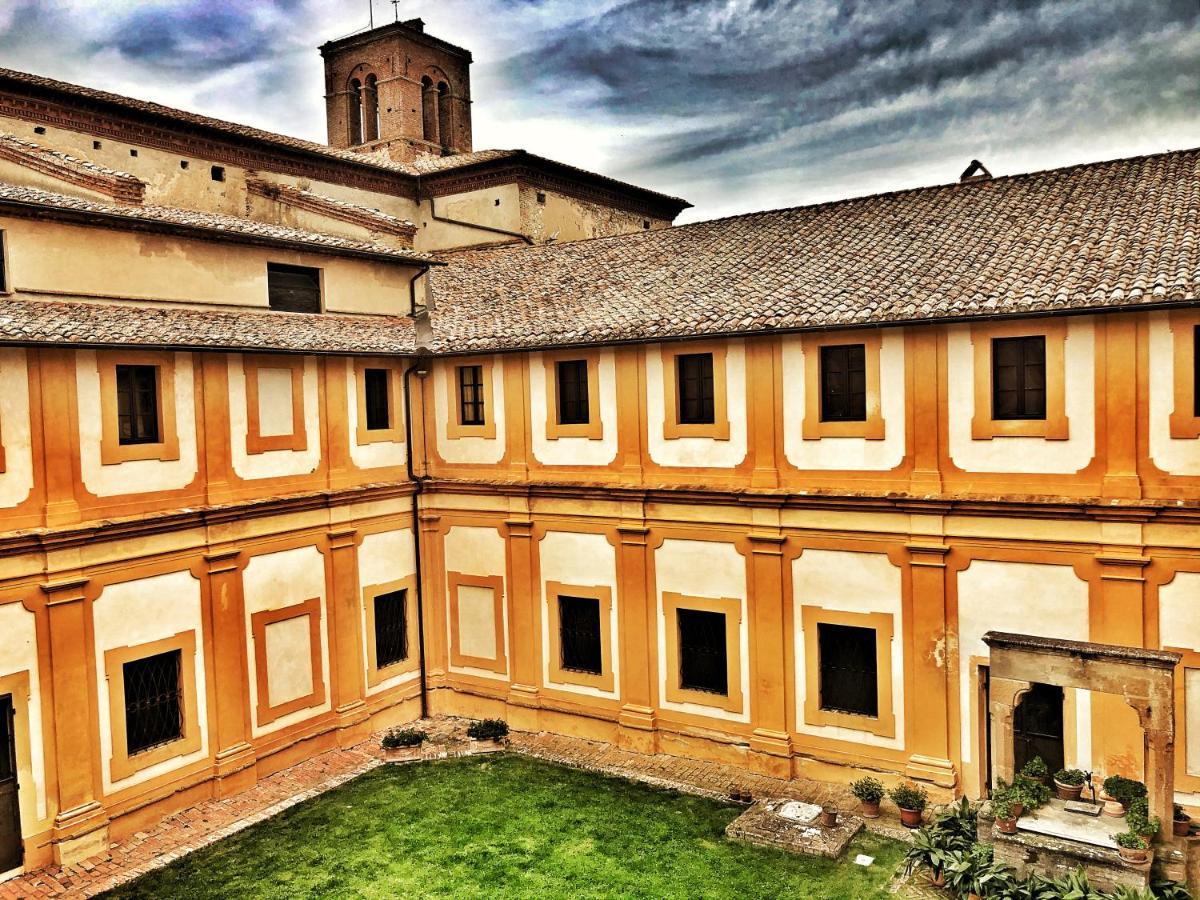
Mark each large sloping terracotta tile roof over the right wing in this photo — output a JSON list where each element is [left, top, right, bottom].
[[430, 149, 1200, 352]]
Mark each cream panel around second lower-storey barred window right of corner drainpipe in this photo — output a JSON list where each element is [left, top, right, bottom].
[[654, 538, 751, 722]]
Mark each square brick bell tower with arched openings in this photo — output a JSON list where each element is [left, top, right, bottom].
[[320, 19, 470, 162]]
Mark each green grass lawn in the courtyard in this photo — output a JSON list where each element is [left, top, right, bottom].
[[107, 755, 904, 900]]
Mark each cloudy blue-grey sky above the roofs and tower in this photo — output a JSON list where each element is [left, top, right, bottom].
[[0, 0, 1200, 220]]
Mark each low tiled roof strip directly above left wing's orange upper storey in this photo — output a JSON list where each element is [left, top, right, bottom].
[[0, 298, 415, 354]]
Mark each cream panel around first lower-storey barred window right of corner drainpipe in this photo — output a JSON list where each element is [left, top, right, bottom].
[[538, 532, 620, 700]]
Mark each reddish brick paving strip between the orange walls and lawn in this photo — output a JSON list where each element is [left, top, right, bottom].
[[0, 718, 926, 900]]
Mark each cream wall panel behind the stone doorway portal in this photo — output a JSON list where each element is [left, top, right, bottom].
[[958, 559, 1092, 769]]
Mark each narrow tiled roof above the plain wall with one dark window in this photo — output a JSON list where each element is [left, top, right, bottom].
[[0, 182, 432, 264]]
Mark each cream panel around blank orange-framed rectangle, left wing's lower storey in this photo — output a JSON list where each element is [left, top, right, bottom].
[[241, 547, 331, 738]]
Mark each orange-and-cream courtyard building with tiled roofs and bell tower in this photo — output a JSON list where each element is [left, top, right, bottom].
[[0, 12, 1200, 877]]
